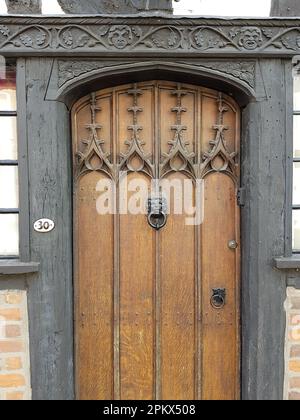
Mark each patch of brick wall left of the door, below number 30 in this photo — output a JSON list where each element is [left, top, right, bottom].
[[0, 290, 31, 400]]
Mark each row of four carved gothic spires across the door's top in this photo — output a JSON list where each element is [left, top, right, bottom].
[[75, 83, 238, 181]]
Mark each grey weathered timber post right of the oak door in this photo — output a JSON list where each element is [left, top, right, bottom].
[[242, 60, 292, 400]]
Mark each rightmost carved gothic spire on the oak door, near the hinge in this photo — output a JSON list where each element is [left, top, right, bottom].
[[201, 93, 237, 181]]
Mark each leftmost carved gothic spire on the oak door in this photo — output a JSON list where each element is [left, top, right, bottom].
[[75, 93, 113, 177]]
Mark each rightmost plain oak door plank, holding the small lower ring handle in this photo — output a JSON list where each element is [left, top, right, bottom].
[[201, 173, 239, 400]]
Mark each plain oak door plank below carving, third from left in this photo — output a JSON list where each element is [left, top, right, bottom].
[[160, 174, 197, 400]]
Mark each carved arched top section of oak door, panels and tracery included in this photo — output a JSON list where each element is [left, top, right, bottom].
[[75, 81, 239, 185]]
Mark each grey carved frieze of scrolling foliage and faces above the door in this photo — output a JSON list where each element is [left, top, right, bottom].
[[0, 17, 300, 54]]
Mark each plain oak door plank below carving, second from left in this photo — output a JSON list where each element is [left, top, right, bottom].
[[120, 174, 156, 400]]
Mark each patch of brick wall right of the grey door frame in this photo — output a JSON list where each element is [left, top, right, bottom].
[[284, 287, 300, 400]]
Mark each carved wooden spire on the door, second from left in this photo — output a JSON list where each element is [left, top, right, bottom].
[[119, 83, 154, 177]]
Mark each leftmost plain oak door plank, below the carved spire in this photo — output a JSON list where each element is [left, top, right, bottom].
[[75, 172, 114, 400]]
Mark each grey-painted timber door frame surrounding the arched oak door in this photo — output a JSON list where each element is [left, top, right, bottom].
[[4, 16, 299, 400]]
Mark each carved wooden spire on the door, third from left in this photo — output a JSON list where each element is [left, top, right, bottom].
[[161, 83, 195, 177]]
